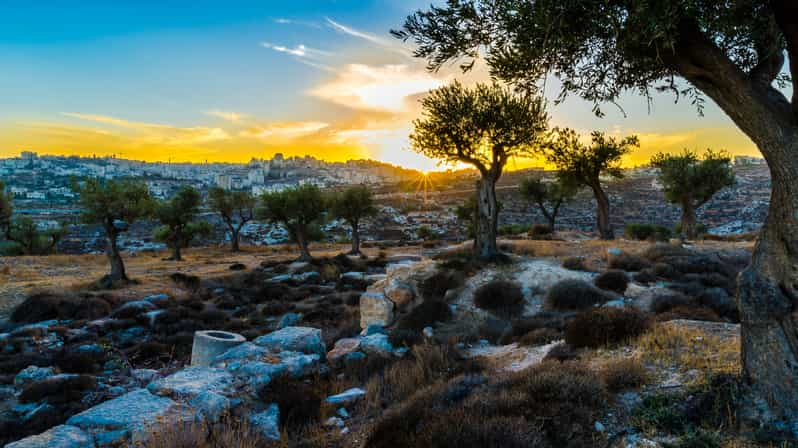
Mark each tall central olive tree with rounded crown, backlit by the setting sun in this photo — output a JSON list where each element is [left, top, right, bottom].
[[410, 82, 548, 259]]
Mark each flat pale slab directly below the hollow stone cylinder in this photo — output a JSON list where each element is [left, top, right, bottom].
[[147, 367, 233, 398]]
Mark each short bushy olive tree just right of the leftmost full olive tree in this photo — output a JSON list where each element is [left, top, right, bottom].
[[155, 187, 213, 261]]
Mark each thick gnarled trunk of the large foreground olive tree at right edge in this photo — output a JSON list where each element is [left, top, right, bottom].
[[738, 136, 798, 430]]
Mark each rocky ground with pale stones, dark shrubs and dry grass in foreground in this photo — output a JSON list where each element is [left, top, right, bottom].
[[0, 240, 780, 448]]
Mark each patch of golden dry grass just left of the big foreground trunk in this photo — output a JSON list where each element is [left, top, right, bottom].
[[635, 321, 740, 374]]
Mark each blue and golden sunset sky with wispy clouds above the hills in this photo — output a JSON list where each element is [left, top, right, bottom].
[[0, 0, 772, 170]]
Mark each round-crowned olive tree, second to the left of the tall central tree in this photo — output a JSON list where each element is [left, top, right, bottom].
[[255, 184, 328, 261]]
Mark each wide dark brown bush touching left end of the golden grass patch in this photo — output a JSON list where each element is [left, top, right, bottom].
[[565, 307, 651, 348]]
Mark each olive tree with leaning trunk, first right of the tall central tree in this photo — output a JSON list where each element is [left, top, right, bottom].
[[546, 129, 640, 240]]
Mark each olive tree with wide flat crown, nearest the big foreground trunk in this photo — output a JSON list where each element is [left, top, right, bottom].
[[651, 149, 734, 238]]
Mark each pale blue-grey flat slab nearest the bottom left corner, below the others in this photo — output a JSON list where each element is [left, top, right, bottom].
[[67, 389, 178, 432]]
